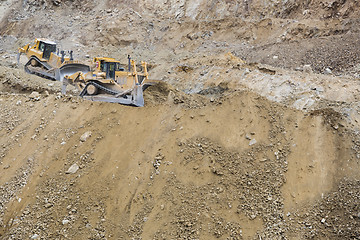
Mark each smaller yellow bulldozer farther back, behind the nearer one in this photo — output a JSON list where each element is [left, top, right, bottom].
[[17, 38, 90, 81]]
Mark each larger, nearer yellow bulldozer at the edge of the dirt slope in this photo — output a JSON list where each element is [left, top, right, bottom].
[[62, 56, 159, 107]]
